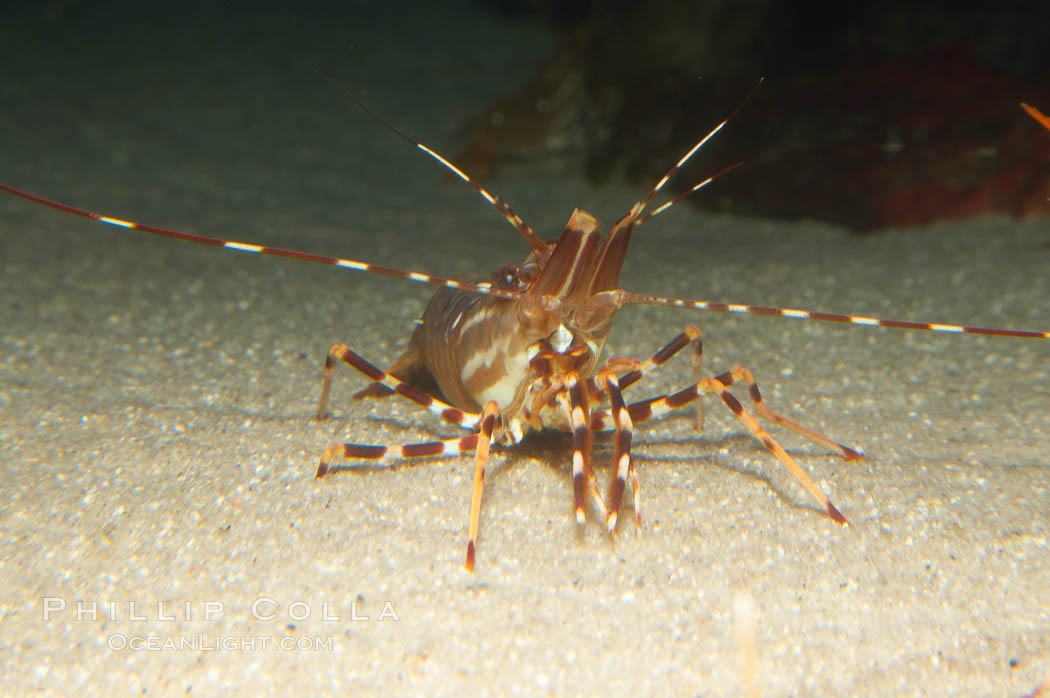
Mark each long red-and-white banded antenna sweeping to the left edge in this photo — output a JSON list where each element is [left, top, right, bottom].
[[0, 184, 520, 299]]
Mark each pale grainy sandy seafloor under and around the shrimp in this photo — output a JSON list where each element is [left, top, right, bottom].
[[0, 4, 1050, 696]]
